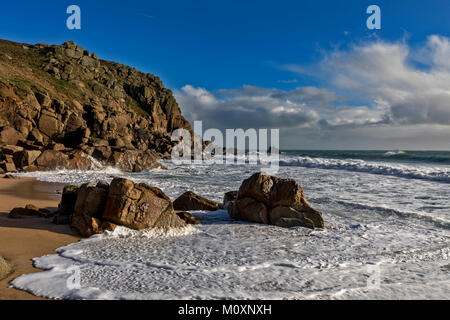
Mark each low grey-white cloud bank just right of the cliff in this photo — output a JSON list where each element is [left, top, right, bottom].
[[175, 85, 319, 129]]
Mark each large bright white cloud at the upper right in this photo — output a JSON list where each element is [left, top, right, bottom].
[[287, 35, 450, 125]]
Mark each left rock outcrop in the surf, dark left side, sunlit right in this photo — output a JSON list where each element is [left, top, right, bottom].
[[55, 178, 185, 237]]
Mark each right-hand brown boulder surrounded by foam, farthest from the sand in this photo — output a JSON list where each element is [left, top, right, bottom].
[[229, 173, 324, 229]]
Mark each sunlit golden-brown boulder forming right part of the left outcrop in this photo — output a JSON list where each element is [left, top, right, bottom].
[[102, 178, 185, 230]]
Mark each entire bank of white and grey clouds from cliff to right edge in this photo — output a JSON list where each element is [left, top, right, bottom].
[[175, 35, 450, 149]]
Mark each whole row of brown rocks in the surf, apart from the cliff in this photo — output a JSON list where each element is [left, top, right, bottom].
[[9, 173, 324, 237]]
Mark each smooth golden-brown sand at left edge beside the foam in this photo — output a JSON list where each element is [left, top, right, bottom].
[[0, 176, 80, 300]]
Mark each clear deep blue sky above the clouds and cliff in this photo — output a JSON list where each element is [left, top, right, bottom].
[[0, 0, 450, 90]]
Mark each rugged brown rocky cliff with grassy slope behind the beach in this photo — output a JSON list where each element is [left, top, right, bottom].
[[0, 40, 192, 171]]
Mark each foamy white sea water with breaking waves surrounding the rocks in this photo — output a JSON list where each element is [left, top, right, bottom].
[[12, 150, 450, 299]]
